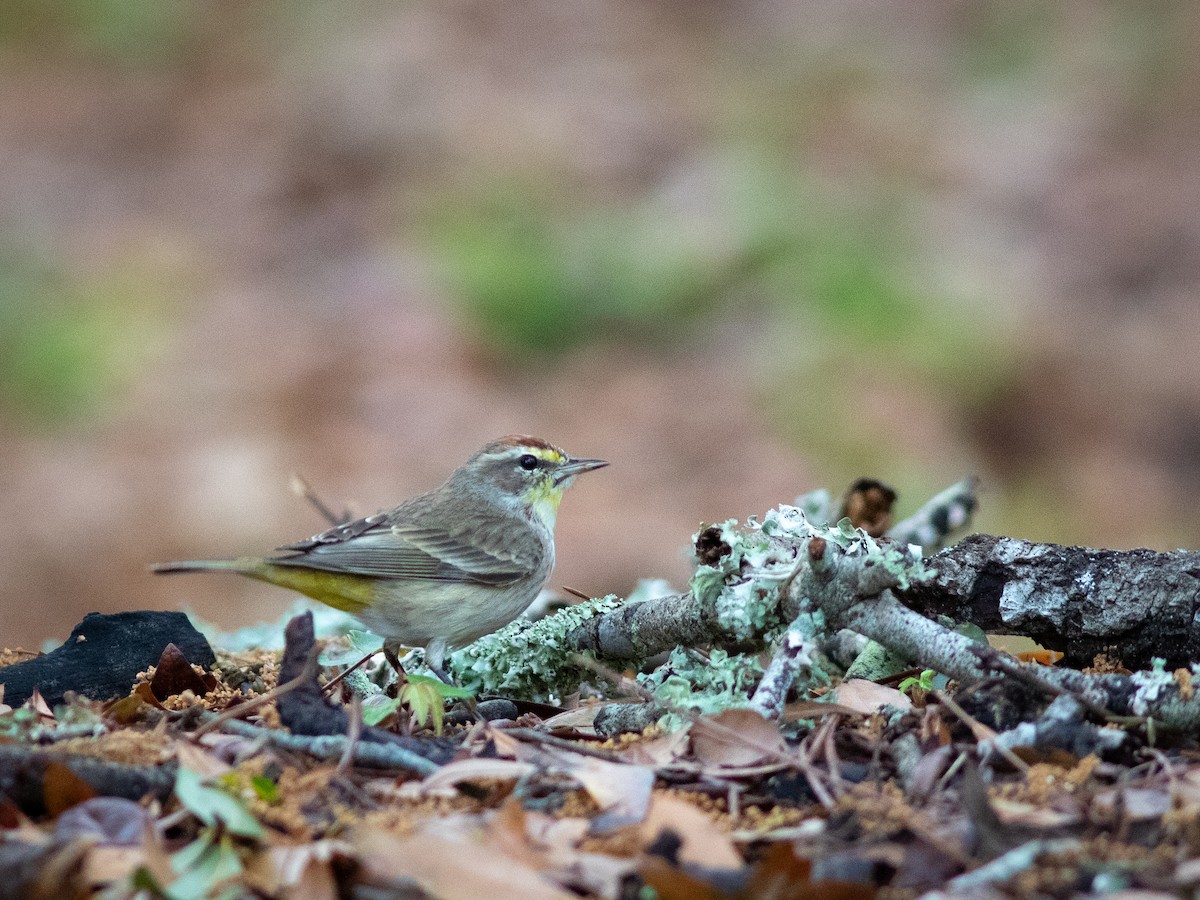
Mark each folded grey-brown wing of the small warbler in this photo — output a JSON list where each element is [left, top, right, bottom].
[[269, 516, 544, 586]]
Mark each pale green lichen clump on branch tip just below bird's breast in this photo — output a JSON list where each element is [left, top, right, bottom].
[[450, 594, 623, 702]]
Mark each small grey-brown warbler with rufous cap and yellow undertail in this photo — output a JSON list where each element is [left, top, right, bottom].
[[151, 434, 608, 674]]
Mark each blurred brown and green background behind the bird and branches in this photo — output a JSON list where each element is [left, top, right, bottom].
[[0, 0, 1200, 647]]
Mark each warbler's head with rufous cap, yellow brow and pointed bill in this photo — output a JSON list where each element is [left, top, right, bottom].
[[456, 434, 608, 530]]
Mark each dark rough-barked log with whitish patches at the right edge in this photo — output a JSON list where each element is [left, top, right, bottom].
[[902, 534, 1200, 670]]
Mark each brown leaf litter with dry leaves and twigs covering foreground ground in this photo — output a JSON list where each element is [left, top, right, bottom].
[[7, 564, 1200, 900]]
